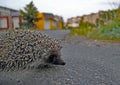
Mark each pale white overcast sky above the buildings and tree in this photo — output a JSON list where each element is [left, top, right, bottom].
[[0, 0, 120, 21]]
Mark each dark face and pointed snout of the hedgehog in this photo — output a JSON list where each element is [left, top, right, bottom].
[[47, 54, 66, 65]]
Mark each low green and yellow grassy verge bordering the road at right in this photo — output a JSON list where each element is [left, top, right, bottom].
[[70, 21, 120, 40]]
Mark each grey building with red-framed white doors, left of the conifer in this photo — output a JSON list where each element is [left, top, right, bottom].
[[0, 6, 22, 30]]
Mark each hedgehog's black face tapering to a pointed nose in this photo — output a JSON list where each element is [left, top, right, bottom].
[[46, 51, 65, 65]]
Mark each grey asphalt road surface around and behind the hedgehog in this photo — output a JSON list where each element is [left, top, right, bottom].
[[0, 30, 120, 85]]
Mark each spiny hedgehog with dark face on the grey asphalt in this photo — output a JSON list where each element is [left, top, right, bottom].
[[0, 30, 65, 71]]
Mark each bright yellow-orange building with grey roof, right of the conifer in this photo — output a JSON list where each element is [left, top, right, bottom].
[[35, 13, 63, 30]]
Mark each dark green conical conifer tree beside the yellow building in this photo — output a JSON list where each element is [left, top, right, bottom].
[[20, 1, 39, 28]]
